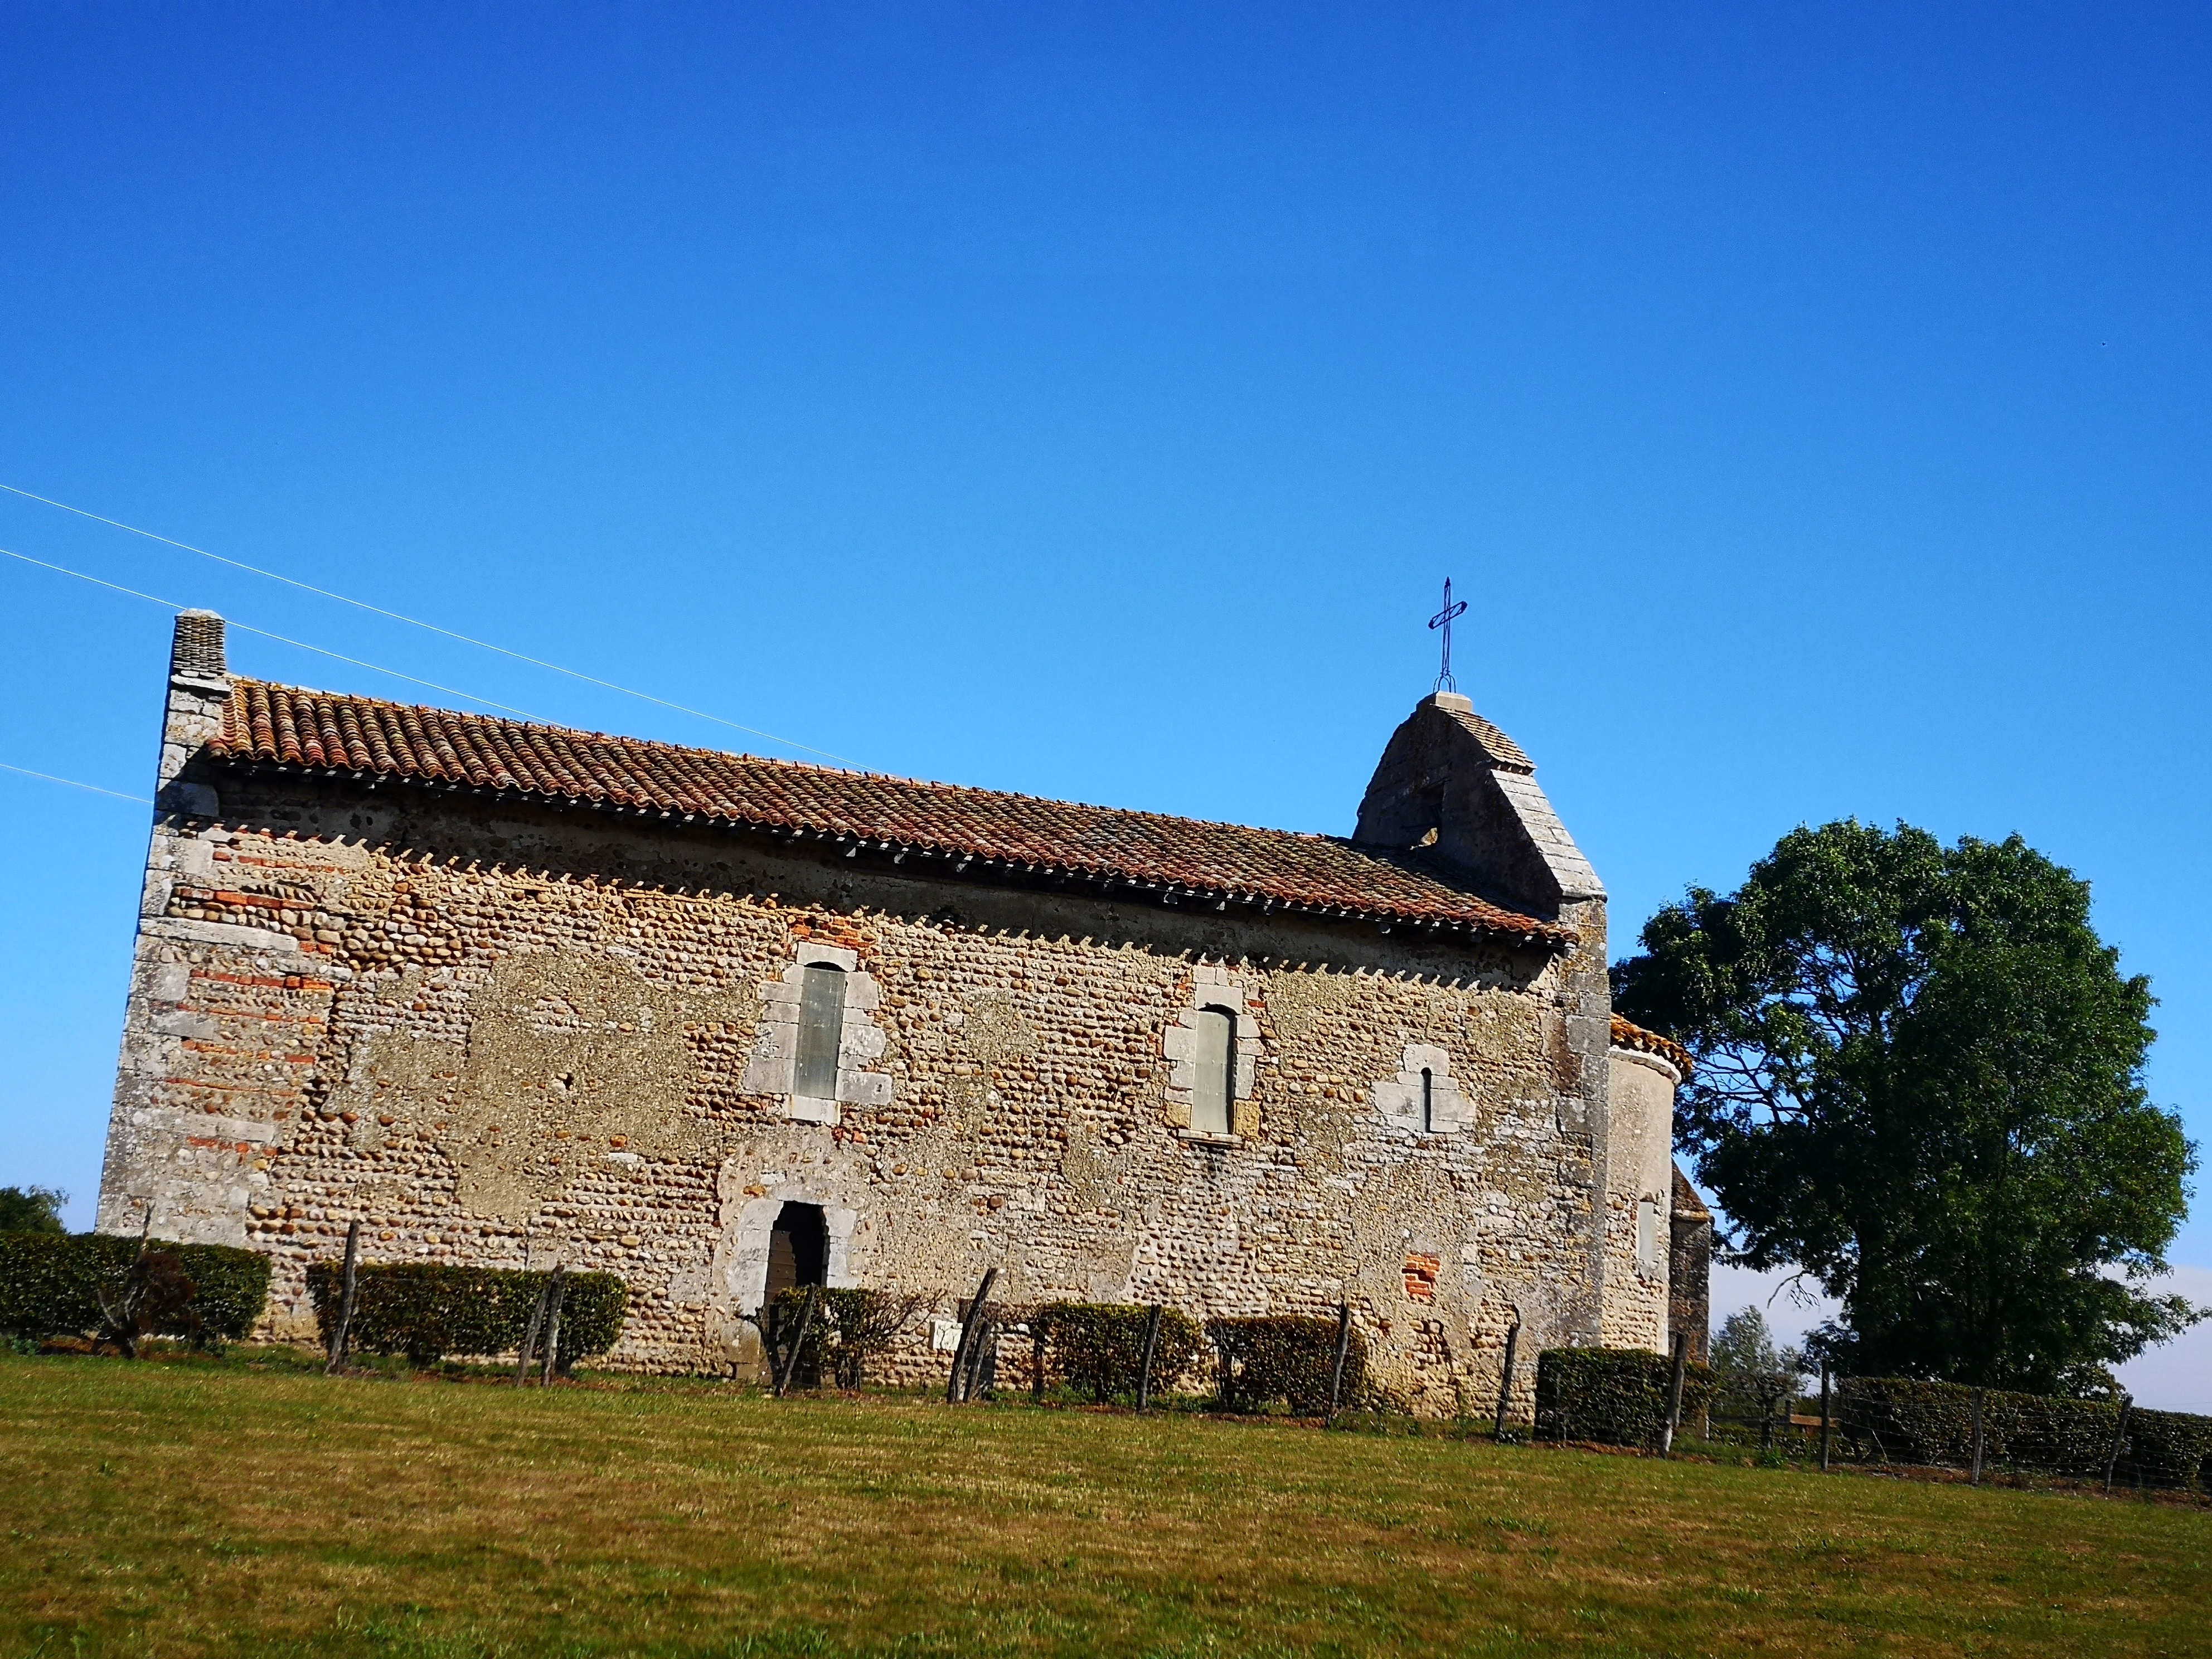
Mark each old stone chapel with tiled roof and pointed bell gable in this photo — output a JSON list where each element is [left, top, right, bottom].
[[100, 613, 1712, 1414]]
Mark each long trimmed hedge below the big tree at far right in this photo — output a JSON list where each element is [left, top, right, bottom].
[[1833, 1376, 2212, 1488]]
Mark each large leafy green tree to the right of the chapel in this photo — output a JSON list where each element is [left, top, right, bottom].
[[1613, 821, 2196, 1394]]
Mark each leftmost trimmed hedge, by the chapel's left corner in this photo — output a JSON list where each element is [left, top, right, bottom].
[[0, 1232, 270, 1343]]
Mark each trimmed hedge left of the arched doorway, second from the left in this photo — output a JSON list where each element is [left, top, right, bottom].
[[308, 1261, 630, 1371]]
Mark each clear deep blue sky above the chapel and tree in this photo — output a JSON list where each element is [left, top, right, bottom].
[[0, 4, 2212, 1389]]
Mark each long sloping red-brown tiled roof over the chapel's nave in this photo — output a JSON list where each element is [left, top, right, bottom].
[[208, 679, 1575, 949]]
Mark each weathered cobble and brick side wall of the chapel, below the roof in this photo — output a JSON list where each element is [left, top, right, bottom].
[[100, 615, 1668, 1414]]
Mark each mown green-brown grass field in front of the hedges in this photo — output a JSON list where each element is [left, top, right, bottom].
[[0, 1356, 2212, 1655]]
